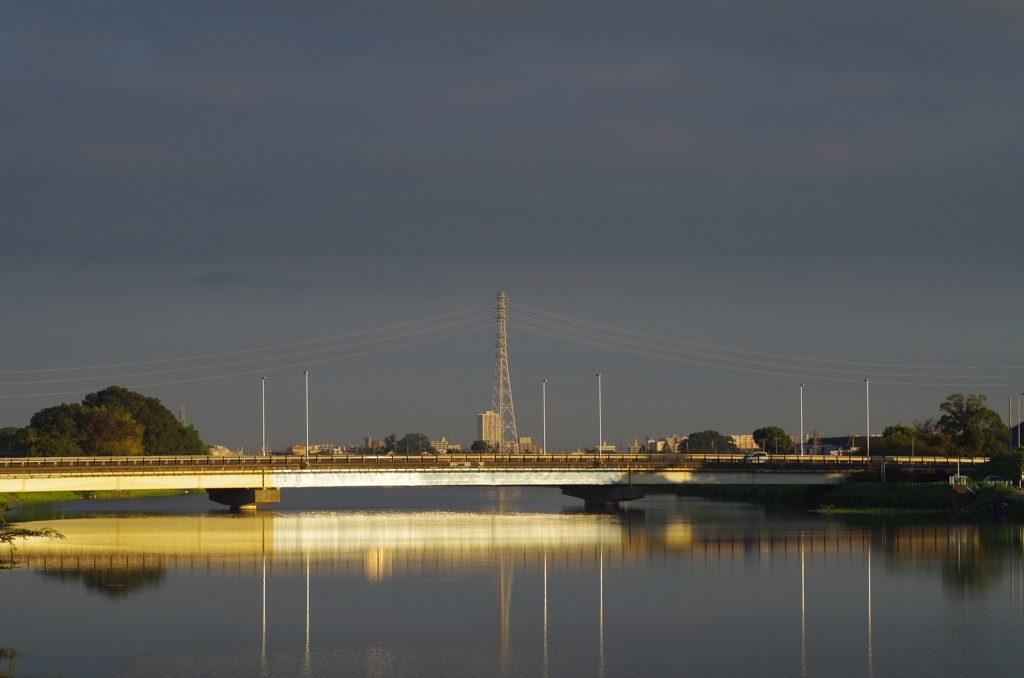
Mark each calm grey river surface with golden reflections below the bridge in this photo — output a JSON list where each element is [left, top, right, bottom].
[[0, 489, 1024, 678]]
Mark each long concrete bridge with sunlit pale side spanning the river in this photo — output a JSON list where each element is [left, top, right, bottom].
[[0, 454, 980, 509]]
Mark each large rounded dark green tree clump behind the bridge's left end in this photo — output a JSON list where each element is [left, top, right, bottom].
[[0, 386, 210, 457]]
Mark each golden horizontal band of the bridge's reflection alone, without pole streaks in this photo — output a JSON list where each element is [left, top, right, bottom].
[[17, 510, 1017, 582]]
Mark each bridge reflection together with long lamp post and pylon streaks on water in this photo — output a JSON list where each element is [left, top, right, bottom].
[[17, 509, 1024, 676]]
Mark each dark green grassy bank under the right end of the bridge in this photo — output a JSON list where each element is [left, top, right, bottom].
[[655, 482, 1010, 511]]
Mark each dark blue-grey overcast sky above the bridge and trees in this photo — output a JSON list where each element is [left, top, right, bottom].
[[0, 0, 1024, 451]]
